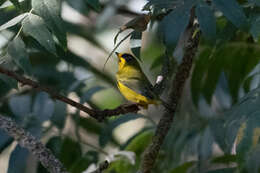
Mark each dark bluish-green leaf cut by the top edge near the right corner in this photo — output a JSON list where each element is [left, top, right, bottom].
[[213, 0, 248, 29]]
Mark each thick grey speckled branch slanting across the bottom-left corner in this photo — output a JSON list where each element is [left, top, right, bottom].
[[0, 115, 68, 173]]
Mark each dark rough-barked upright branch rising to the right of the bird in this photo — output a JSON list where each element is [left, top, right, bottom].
[[141, 12, 200, 173]]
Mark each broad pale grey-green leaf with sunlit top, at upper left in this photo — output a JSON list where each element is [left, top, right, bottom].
[[22, 14, 56, 54]]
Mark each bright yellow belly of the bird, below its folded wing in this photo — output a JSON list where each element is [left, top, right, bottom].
[[117, 81, 157, 108]]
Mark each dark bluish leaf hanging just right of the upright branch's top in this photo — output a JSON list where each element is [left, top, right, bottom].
[[196, 2, 216, 41]]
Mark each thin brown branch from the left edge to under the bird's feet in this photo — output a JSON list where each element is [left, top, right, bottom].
[[0, 66, 139, 121]]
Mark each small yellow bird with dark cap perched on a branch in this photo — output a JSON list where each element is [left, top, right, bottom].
[[116, 52, 160, 109]]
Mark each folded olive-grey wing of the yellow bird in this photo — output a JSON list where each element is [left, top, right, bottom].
[[119, 77, 156, 99]]
